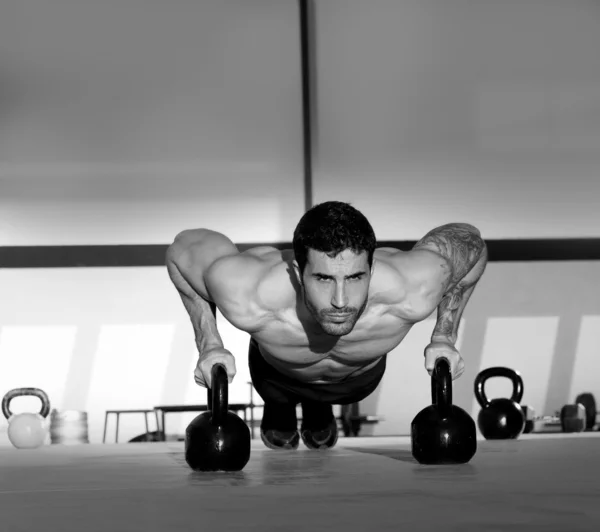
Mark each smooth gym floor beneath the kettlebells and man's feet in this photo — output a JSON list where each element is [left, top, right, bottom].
[[0, 432, 600, 532]]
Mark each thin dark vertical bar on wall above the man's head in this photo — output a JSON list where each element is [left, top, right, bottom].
[[298, 0, 313, 210]]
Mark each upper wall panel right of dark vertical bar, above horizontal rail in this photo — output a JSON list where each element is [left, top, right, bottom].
[[314, 0, 600, 240]]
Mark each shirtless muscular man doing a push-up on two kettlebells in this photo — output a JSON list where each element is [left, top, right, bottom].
[[167, 201, 487, 449]]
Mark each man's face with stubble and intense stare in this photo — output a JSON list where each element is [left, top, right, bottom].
[[296, 249, 373, 336]]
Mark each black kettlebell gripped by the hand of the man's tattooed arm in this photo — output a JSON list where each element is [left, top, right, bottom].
[[410, 357, 477, 464]]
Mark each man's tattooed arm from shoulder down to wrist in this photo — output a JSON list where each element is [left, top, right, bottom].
[[413, 223, 488, 347]]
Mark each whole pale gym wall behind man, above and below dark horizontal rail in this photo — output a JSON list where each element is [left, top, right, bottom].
[[0, 0, 600, 441]]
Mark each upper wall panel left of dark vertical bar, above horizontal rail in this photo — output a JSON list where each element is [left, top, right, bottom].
[[0, 0, 304, 245]]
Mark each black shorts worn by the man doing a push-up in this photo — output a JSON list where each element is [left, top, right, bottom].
[[248, 338, 387, 405]]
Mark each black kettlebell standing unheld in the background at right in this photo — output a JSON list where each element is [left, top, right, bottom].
[[475, 367, 525, 440]]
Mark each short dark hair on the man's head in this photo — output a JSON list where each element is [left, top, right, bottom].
[[293, 201, 377, 273]]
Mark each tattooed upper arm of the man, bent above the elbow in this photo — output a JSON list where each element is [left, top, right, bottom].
[[413, 223, 485, 285]]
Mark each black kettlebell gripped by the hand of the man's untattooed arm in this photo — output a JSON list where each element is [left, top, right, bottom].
[[185, 364, 250, 471]]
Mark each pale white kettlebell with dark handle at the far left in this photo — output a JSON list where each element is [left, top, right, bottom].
[[2, 388, 50, 449]]
